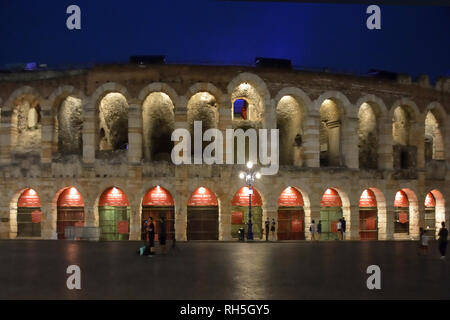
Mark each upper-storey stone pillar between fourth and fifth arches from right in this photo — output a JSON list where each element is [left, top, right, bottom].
[[303, 114, 320, 168]]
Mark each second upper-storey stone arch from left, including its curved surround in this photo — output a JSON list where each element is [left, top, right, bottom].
[[48, 85, 86, 155]]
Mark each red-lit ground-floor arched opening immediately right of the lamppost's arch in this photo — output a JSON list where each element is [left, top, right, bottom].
[[277, 187, 305, 240]]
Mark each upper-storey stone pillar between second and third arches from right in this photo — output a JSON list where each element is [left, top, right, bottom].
[[378, 116, 394, 170]]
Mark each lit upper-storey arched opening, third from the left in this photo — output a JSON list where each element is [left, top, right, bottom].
[[99, 92, 128, 151]]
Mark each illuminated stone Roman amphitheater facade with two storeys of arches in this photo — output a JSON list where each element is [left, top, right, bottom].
[[0, 65, 450, 240]]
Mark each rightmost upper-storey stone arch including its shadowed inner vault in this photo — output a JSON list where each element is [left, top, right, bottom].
[[424, 101, 447, 162]]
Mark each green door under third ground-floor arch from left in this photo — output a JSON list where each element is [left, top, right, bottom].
[[98, 206, 130, 241]]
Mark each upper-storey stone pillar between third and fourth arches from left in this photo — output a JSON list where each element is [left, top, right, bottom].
[[128, 104, 142, 165]]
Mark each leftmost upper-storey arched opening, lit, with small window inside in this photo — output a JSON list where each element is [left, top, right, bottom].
[[11, 94, 42, 152]]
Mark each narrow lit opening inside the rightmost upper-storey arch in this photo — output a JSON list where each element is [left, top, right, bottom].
[[425, 110, 445, 162]]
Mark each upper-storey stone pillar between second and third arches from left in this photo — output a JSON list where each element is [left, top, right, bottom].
[[83, 98, 98, 165]]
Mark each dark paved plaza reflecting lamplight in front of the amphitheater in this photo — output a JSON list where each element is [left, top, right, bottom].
[[0, 240, 450, 300]]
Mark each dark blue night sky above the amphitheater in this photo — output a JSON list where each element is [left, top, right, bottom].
[[0, 0, 450, 77]]
